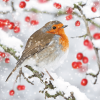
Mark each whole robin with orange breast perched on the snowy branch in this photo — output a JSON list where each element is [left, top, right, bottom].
[[6, 21, 69, 81]]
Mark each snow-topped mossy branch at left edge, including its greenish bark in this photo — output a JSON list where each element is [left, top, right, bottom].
[[0, 29, 23, 60]]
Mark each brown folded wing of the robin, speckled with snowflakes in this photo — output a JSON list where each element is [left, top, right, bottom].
[[17, 30, 54, 65]]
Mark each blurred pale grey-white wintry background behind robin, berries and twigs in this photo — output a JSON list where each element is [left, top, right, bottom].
[[0, 0, 100, 100]]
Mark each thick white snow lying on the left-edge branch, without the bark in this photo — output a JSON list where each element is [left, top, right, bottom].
[[0, 29, 23, 56]]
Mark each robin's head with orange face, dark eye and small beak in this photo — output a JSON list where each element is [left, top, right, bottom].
[[42, 21, 67, 35]]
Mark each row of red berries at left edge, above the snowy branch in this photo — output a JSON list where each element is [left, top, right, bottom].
[[0, 19, 20, 33]]
